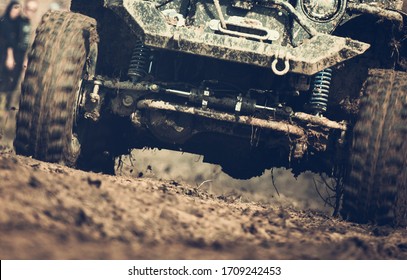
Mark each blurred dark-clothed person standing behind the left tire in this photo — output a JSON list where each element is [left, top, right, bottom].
[[0, 0, 38, 109]]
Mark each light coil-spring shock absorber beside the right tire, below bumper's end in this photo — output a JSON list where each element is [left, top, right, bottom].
[[309, 68, 332, 115]]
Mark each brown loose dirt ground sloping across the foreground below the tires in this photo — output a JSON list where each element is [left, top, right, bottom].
[[0, 148, 407, 259]]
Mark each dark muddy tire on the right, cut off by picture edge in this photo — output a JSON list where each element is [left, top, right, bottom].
[[342, 69, 407, 226]]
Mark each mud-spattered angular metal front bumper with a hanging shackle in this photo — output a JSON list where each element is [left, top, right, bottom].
[[105, 0, 370, 75]]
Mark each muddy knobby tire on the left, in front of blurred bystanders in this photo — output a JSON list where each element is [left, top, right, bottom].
[[14, 12, 96, 166]]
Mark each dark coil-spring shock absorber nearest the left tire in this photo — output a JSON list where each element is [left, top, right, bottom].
[[127, 40, 151, 82]]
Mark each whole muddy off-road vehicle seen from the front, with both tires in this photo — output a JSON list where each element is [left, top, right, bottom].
[[14, 0, 407, 225]]
